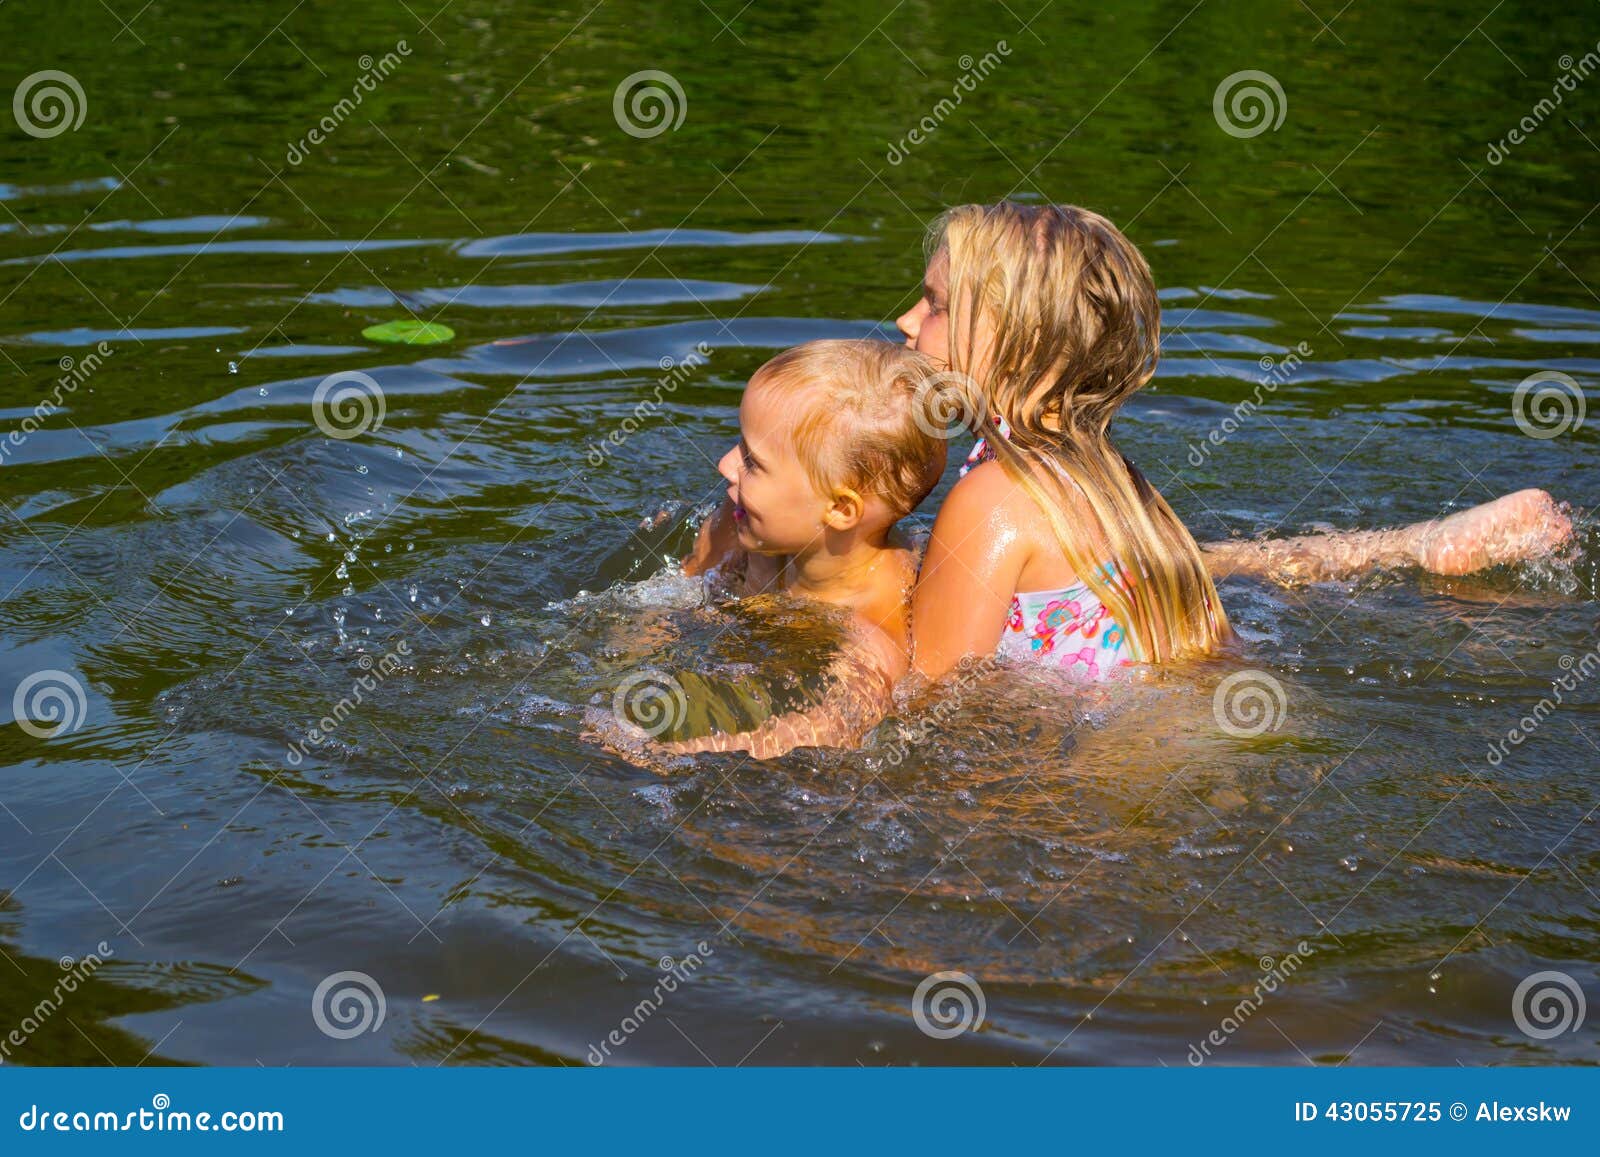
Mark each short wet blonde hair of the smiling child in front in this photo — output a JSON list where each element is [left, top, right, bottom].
[[750, 338, 946, 517]]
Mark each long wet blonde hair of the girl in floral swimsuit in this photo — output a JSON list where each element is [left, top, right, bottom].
[[926, 202, 1232, 663]]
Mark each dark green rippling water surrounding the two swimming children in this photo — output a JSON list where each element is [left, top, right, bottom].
[[0, 0, 1600, 1064]]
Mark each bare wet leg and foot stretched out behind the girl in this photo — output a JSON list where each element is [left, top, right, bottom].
[[1202, 490, 1573, 584]]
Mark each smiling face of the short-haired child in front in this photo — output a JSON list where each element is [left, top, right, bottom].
[[717, 379, 830, 554]]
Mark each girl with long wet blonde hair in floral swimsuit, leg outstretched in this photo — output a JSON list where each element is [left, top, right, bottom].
[[898, 202, 1570, 679]]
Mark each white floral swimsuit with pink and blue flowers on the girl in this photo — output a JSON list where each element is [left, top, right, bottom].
[[962, 418, 1133, 680]]
